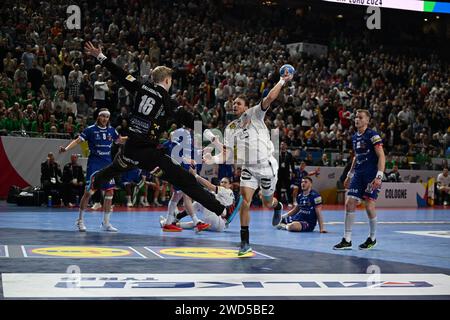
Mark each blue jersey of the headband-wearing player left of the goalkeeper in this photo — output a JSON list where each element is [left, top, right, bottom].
[[80, 124, 119, 164]]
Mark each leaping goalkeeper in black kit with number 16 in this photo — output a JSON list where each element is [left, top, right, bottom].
[[85, 42, 239, 218]]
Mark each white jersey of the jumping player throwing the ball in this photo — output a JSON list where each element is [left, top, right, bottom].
[[224, 103, 275, 165]]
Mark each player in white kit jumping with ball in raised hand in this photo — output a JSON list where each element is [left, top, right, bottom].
[[204, 70, 293, 256]]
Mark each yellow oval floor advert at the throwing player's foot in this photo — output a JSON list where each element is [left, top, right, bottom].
[[145, 247, 274, 259]]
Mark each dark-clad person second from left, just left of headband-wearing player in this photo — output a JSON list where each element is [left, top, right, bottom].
[[62, 154, 85, 207]]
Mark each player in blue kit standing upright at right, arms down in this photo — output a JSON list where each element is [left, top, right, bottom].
[[333, 109, 385, 250]]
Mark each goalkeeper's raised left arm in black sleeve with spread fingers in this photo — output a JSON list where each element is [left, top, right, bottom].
[[84, 41, 142, 92]]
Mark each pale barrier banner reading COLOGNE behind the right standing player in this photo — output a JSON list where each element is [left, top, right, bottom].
[[377, 182, 426, 208]]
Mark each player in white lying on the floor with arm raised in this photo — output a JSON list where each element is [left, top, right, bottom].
[[160, 169, 234, 232]]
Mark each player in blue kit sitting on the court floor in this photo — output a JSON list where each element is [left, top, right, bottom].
[[274, 177, 327, 233]]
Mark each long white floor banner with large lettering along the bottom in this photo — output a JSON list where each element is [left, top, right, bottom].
[[2, 273, 450, 298]]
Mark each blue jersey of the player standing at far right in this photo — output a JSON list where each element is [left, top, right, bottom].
[[352, 129, 383, 174]]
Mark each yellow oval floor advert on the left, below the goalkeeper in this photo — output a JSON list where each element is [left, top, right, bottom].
[[23, 245, 145, 259]]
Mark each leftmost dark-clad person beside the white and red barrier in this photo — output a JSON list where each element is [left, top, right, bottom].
[[41, 152, 62, 204]]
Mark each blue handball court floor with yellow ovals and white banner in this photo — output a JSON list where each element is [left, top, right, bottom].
[[0, 202, 450, 300]]
